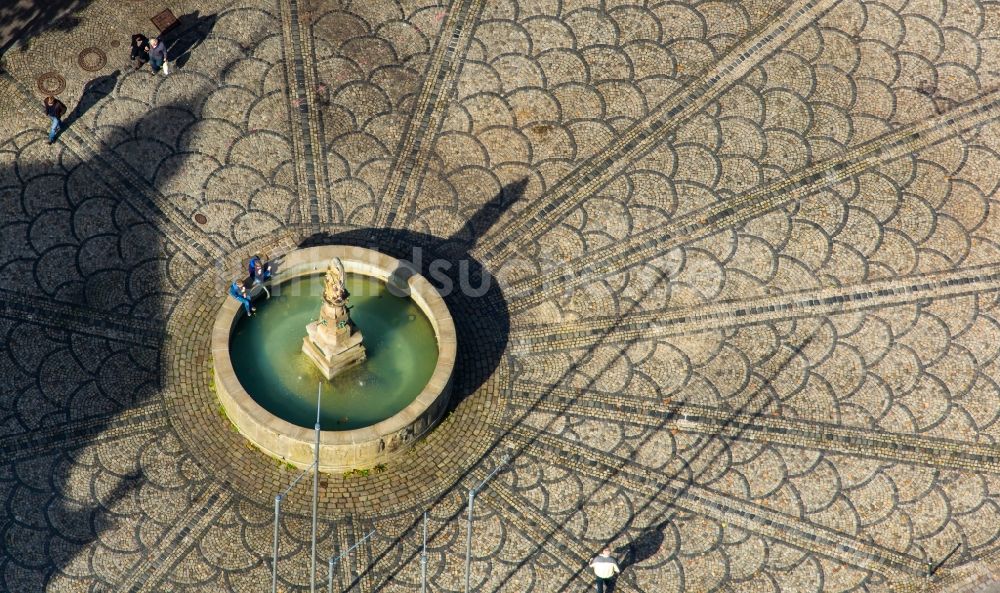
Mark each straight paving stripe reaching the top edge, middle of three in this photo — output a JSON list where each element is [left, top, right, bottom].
[[372, 0, 485, 229]]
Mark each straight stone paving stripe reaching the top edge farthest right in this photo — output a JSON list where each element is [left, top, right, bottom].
[[476, 0, 839, 264]]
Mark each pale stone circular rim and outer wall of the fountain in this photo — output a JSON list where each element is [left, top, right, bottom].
[[217, 245, 457, 471]]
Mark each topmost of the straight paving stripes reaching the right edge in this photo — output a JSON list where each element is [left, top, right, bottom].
[[507, 91, 1000, 311]]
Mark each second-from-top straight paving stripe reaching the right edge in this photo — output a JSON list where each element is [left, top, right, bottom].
[[510, 265, 1000, 355]]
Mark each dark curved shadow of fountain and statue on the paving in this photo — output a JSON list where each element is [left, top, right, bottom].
[[299, 179, 528, 409]]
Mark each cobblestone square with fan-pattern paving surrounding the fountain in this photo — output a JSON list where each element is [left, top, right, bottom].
[[0, 0, 1000, 593]]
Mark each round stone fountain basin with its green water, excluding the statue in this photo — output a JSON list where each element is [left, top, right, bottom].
[[212, 246, 456, 472]]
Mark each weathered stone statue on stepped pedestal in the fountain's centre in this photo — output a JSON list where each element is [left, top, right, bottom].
[[302, 257, 365, 380]]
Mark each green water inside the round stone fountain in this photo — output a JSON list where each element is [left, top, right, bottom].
[[229, 274, 438, 430]]
